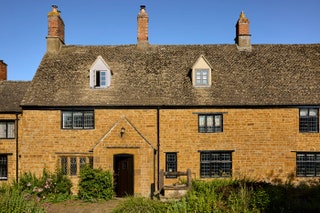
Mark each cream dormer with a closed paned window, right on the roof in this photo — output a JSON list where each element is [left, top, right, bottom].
[[192, 55, 212, 87]]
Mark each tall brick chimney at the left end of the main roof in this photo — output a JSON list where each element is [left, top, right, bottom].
[[47, 5, 64, 53]]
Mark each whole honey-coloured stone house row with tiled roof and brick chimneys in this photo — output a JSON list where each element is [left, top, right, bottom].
[[0, 6, 320, 196]]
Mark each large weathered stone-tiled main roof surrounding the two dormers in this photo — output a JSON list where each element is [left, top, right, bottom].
[[22, 44, 320, 107]]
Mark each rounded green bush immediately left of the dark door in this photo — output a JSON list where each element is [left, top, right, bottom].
[[78, 166, 113, 201]]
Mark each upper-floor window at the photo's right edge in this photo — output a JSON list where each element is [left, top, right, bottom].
[[299, 108, 319, 132]]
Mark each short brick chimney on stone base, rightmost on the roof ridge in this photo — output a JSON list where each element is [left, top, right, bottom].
[[235, 11, 251, 50]]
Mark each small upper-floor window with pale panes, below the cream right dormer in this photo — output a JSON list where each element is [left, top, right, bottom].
[[198, 114, 223, 133]]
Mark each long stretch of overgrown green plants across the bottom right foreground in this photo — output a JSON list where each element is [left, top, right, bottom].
[[114, 179, 320, 213]]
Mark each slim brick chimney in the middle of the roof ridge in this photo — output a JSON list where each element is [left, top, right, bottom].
[[137, 5, 149, 47]]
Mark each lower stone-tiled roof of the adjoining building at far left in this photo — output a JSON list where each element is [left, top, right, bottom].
[[0, 81, 30, 113]]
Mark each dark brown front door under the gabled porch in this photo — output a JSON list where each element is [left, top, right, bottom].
[[113, 154, 133, 197]]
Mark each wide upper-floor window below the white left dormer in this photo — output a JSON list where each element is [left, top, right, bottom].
[[62, 111, 94, 129]]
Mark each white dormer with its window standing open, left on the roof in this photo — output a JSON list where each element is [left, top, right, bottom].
[[90, 56, 112, 88]]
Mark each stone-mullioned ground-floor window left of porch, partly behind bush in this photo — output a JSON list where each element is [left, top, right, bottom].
[[60, 156, 93, 176]]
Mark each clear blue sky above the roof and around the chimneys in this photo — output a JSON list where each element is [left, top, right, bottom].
[[0, 0, 320, 80]]
